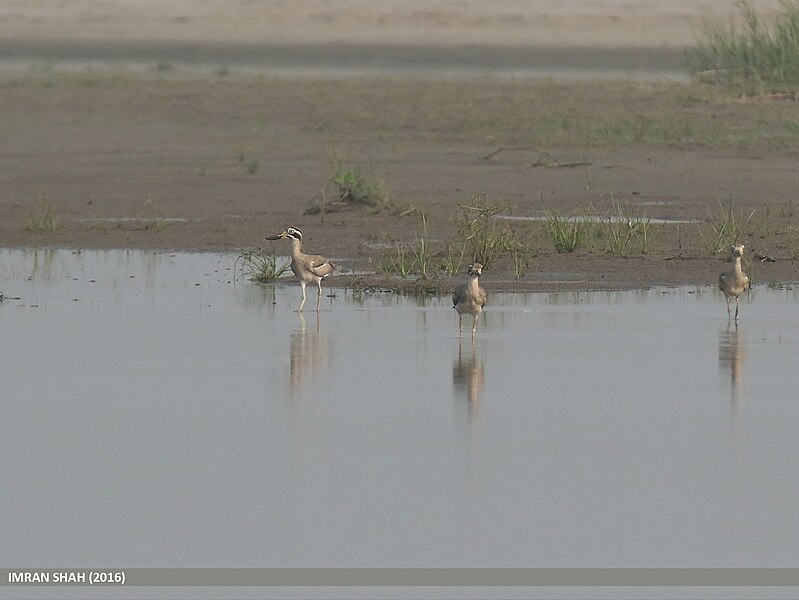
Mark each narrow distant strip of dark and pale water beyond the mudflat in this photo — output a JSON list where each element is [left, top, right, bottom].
[[0, 40, 689, 82]]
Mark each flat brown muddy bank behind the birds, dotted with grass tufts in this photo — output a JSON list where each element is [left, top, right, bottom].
[[0, 67, 799, 290]]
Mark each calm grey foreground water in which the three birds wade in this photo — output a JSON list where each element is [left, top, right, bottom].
[[0, 250, 799, 568]]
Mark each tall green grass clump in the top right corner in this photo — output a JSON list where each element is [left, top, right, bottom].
[[686, 0, 799, 94]]
